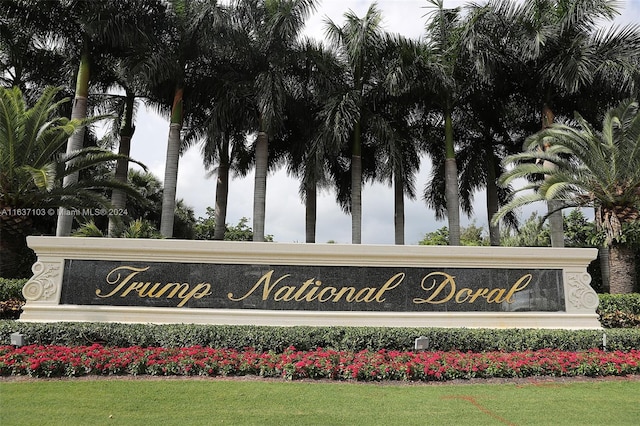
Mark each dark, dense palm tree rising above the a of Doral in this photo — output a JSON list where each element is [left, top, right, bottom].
[[450, 0, 538, 246]]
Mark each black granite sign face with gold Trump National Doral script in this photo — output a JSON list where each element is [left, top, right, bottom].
[[60, 260, 565, 312]]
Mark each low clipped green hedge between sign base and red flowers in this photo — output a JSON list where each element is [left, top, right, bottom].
[[0, 320, 640, 352]]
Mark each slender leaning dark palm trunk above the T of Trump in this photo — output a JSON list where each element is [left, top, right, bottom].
[[108, 91, 135, 237]]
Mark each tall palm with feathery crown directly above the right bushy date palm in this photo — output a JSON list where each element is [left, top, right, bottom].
[[513, 0, 640, 247]]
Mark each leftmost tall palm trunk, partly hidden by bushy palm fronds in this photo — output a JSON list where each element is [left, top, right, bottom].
[[56, 47, 89, 237]]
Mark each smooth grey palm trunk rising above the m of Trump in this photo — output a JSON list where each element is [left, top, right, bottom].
[[160, 87, 183, 238]]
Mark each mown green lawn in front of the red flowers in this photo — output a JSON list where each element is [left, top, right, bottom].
[[0, 379, 640, 426]]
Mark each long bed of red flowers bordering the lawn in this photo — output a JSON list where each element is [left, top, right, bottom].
[[0, 344, 640, 381]]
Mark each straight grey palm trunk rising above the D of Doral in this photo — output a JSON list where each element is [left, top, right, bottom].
[[444, 109, 460, 246]]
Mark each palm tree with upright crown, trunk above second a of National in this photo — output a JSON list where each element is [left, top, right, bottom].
[[323, 3, 384, 244]]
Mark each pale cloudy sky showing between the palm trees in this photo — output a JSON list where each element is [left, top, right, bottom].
[[125, 0, 640, 244]]
